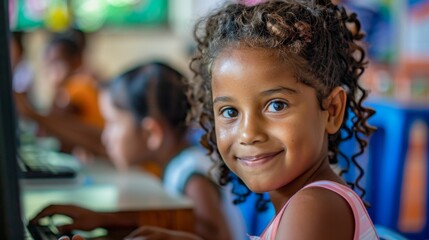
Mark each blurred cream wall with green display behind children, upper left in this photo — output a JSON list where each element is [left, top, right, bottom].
[[9, 0, 222, 109]]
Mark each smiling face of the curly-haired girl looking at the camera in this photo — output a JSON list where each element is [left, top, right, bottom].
[[212, 48, 329, 192]]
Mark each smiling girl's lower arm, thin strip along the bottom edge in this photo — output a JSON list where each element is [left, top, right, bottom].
[[124, 226, 202, 240]]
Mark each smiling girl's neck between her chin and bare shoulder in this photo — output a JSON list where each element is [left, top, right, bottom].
[[269, 156, 344, 213]]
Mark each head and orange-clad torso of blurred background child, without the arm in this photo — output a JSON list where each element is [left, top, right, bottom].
[[45, 35, 104, 128]]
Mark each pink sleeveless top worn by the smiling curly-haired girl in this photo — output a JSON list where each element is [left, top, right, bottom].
[[250, 181, 379, 240]]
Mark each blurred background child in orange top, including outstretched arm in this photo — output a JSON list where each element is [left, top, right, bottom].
[[17, 34, 105, 160]]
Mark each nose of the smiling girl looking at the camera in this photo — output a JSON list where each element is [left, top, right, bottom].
[[239, 115, 267, 145]]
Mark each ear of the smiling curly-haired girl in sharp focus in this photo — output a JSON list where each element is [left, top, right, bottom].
[[324, 87, 347, 134]]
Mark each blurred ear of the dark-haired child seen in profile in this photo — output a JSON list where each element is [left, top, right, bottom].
[[141, 117, 164, 151]]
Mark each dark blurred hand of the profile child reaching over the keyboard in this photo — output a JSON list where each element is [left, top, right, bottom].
[[31, 205, 104, 233]]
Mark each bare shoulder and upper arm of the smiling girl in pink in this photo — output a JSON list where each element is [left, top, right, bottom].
[[277, 183, 355, 239]]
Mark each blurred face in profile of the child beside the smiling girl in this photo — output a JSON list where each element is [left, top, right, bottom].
[[100, 91, 147, 170]]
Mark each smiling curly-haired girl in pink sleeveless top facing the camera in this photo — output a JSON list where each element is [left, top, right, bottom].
[[184, 0, 378, 240]]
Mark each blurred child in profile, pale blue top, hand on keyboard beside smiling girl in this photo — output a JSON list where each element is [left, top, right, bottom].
[[33, 62, 245, 239]]
